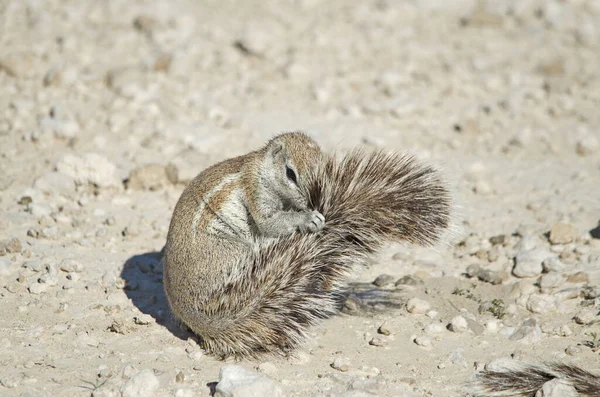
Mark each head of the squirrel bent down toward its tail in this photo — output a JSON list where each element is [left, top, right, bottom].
[[261, 132, 323, 210]]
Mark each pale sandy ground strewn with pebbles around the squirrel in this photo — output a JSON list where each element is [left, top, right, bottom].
[[0, 0, 600, 397]]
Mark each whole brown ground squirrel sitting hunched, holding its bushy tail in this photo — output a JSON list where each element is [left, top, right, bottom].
[[163, 133, 451, 357]]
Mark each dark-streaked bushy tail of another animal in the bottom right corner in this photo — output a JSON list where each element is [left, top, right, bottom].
[[474, 363, 600, 397]]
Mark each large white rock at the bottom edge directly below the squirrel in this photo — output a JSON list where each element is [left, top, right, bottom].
[[214, 365, 283, 397]]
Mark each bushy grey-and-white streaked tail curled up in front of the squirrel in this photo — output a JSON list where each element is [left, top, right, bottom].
[[197, 150, 451, 357]]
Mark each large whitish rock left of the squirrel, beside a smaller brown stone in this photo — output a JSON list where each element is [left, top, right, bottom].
[[56, 153, 121, 188]]
